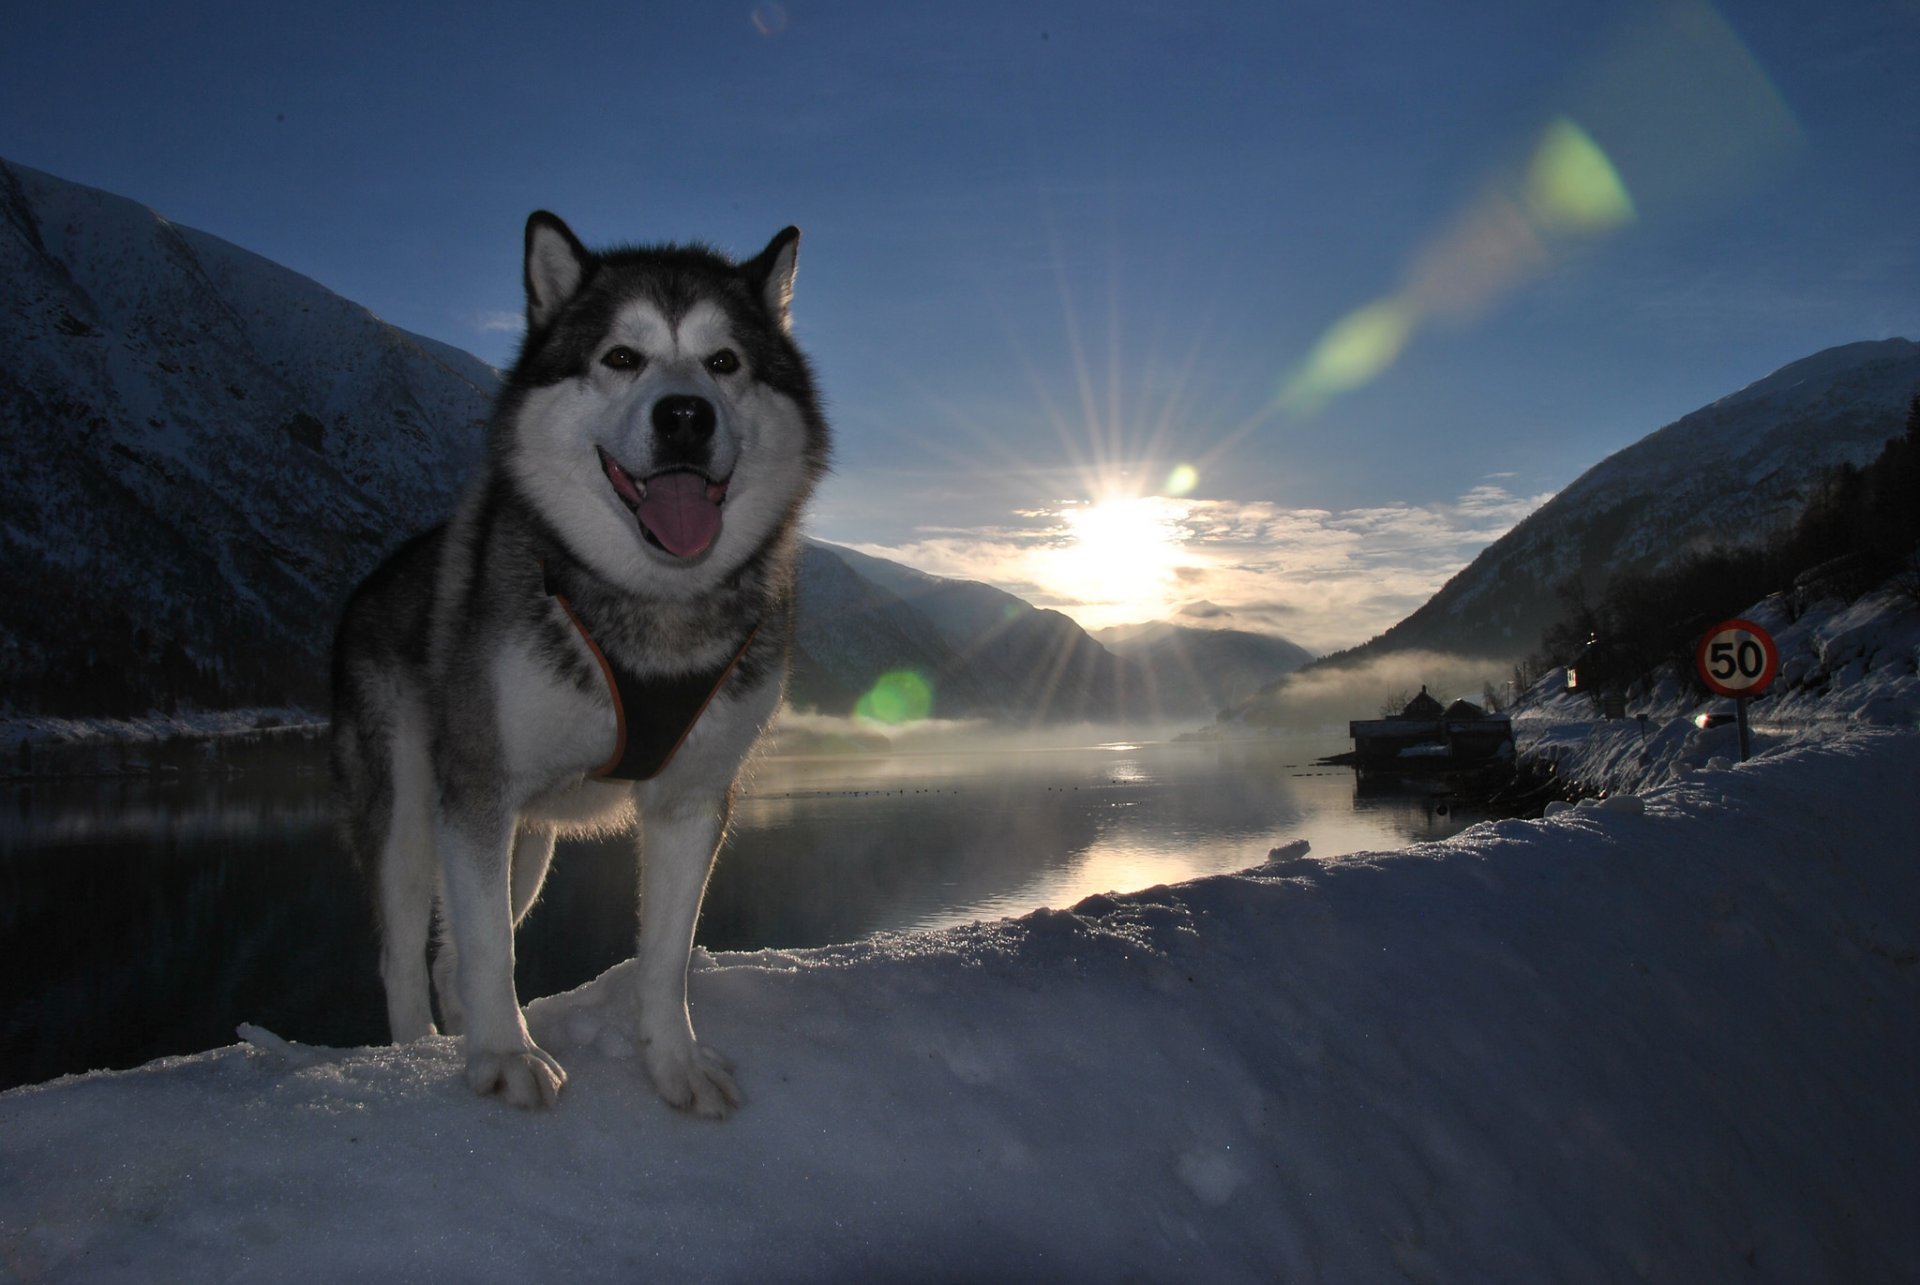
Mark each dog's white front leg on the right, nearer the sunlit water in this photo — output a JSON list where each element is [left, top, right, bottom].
[[639, 799, 741, 1120]]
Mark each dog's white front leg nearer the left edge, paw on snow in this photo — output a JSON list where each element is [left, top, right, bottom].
[[436, 816, 566, 1106]]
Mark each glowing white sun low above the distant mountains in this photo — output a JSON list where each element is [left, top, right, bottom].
[[1039, 496, 1187, 628]]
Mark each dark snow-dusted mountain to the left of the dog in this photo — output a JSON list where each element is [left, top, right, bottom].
[[0, 161, 497, 709]]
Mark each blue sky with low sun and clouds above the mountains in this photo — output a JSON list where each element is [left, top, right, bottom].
[[11, 0, 1920, 651]]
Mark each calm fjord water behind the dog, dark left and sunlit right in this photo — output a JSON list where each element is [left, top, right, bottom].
[[0, 739, 1476, 1087]]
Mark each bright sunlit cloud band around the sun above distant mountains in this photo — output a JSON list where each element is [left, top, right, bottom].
[[856, 478, 1551, 651]]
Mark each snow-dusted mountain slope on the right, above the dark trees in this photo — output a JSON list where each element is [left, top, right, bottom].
[[1348, 338, 1920, 657]]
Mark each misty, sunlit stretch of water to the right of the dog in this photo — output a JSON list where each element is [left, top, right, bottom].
[[721, 738, 1467, 949]]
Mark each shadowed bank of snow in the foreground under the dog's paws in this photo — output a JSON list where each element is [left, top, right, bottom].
[[11, 597, 1920, 1281]]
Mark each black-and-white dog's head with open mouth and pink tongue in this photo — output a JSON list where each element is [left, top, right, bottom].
[[495, 211, 828, 597]]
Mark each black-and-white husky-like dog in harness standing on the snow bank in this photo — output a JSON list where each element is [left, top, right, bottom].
[[332, 211, 828, 1116]]
